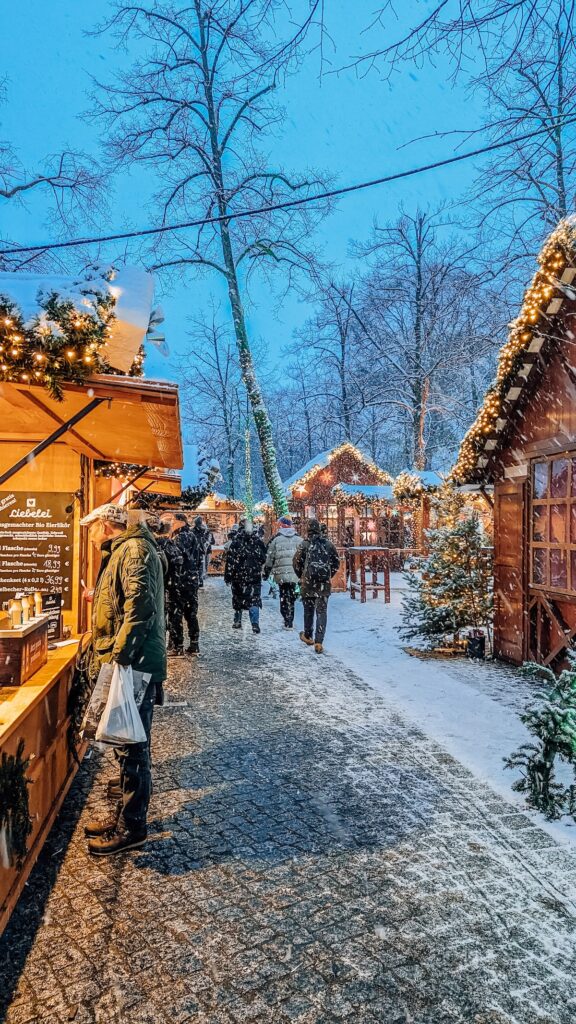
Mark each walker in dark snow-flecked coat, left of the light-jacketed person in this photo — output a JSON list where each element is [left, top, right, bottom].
[[224, 519, 266, 633]]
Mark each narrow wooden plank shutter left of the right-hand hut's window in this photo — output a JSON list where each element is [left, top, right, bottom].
[[487, 480, 527, 665]]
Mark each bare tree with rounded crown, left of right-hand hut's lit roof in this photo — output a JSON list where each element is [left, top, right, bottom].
[[356, 211, 505, 469]]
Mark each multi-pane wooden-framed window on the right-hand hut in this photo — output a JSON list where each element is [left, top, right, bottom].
[[530, 454, 576, 593]]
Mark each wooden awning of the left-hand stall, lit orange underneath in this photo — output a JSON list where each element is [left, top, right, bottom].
[[0, 374, 183, 469]]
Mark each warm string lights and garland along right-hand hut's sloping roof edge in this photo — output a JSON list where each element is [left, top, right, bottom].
[[452, 218, 576, 483]]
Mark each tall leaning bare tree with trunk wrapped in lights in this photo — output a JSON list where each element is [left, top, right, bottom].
[[91, 0, 325, 513]]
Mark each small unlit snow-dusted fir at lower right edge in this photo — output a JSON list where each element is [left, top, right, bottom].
[[504, 651, 576, 819]]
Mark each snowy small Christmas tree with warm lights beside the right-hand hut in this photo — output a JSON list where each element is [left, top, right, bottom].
[[400, 509, 492, 646]]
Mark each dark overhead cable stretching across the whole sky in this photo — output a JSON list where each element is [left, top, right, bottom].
[[0, 117, 576, 256]]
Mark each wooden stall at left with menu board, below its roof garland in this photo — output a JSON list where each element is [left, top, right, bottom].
[[0, 375, 182, 932]]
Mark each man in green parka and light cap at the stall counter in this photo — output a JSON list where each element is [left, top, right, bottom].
[[81, 504, 166, 857]]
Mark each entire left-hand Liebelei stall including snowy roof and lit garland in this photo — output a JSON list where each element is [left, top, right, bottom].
[[0, 269, 182, 932]]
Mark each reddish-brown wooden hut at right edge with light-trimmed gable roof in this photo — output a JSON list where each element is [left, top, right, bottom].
[[453, 218, 576, 669]]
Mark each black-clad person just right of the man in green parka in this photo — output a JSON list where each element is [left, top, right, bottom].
[[168, 512, 204, 657]]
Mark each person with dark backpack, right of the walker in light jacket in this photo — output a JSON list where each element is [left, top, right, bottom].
[[293, 519, 340, 654]]
